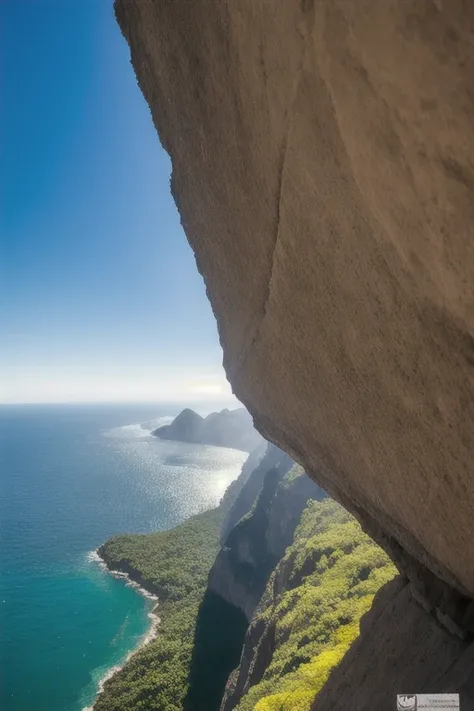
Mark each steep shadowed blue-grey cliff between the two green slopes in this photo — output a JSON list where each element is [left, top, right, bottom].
[[185, 454, 326, 711]]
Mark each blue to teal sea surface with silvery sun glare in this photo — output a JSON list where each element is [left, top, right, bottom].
[[0, 405, 246, 711]]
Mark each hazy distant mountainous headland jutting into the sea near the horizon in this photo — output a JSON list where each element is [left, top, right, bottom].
[[152, 407, 263, 452]]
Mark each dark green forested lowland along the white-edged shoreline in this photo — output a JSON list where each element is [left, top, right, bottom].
[[94, 509, 222, 711]]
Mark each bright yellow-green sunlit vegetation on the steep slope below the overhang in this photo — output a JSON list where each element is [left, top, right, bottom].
[[233, 500, 396, 711]]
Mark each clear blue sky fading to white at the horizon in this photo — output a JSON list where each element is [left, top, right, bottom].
[[0, 0, 237, 402]]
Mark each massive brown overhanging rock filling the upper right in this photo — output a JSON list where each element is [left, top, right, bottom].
[[116, 0, 474, 596]]
